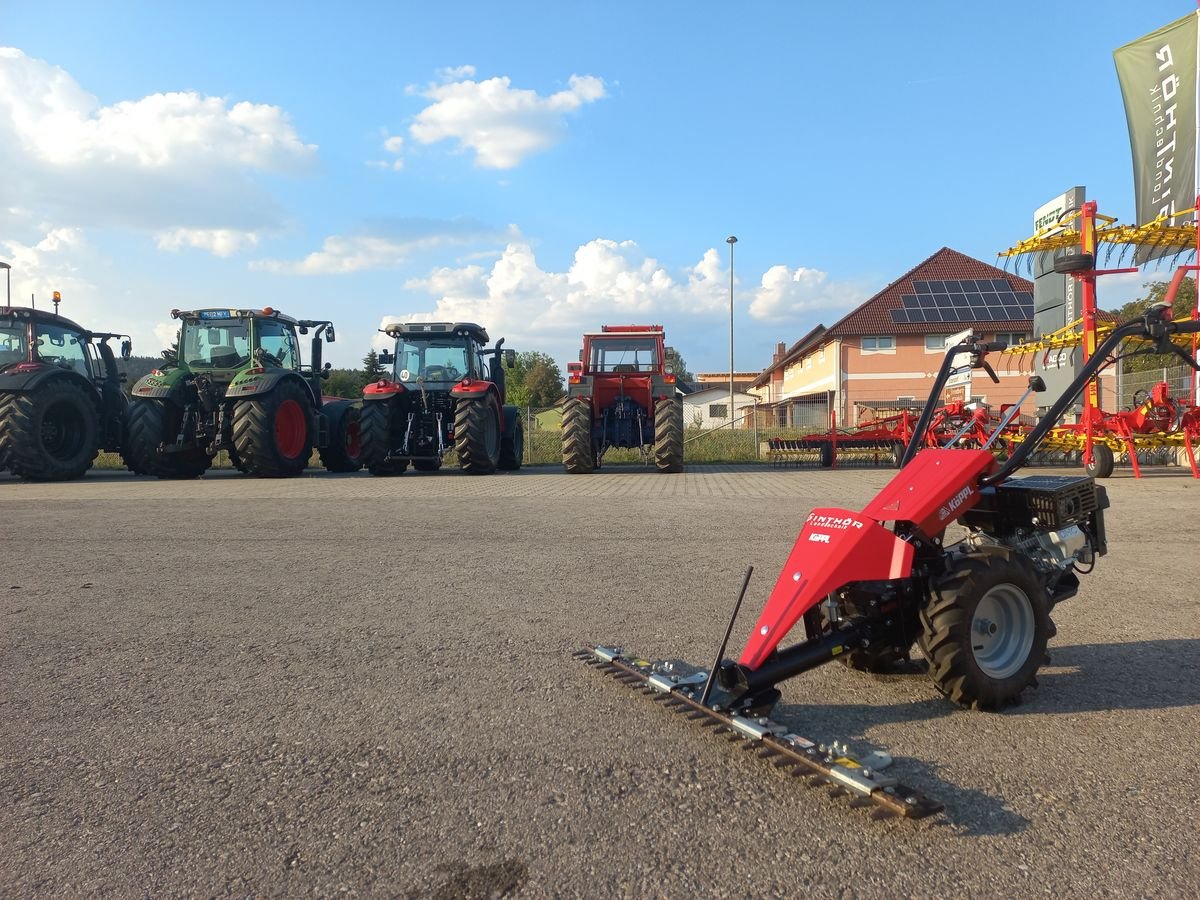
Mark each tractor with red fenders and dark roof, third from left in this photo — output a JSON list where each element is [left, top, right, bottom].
[[361, 322, 524, 475]]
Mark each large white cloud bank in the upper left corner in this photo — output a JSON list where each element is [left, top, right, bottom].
[[0, 47, 317, 243]]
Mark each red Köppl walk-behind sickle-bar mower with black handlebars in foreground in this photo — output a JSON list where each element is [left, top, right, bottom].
[[577, 278, 1200, 818]]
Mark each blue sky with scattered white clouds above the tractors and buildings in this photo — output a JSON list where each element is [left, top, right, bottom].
[[0, 0, 1195, 372]]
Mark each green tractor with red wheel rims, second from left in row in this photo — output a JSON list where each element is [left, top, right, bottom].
[[124, 307, 361, 479]]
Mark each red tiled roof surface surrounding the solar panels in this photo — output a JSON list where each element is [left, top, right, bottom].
[[824, 247, 1033, 337]]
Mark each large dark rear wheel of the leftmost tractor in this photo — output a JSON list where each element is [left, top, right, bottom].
[[0, 379, 100, 481]]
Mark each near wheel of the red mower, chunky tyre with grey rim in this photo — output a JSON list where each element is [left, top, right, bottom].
[[918, 551, 1055, 709]]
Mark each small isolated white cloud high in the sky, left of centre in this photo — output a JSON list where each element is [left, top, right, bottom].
[[409, 67, 606, 169]]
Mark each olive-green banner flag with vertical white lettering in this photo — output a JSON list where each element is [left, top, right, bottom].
[[1112, 12, 1200, 263]]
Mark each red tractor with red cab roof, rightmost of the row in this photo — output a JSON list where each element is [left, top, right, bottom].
[[563, 325, 683, 475]]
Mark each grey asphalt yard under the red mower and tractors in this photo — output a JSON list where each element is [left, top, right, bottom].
[[0, 467, 1200, 898]]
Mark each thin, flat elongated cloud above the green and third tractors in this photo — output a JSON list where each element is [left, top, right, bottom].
[[250, 218, 515, 275]]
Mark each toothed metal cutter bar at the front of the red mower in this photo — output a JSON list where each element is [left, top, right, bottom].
[[575, 647, 942, 818]]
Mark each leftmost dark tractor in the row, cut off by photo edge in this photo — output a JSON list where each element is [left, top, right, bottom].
[[0, 292, 131, 481]]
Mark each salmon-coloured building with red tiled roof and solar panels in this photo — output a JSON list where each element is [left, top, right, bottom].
[[751, 247, 1033, 427]]
